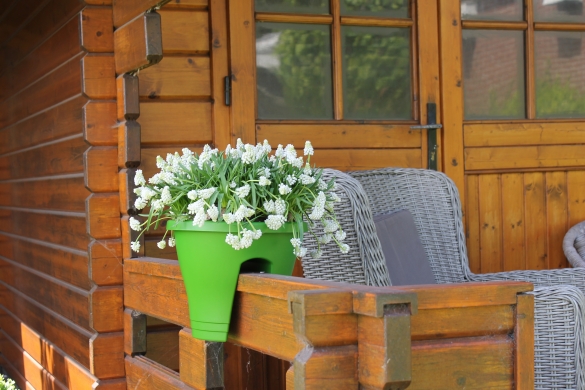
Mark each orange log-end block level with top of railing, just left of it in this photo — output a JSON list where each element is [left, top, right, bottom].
[[88, 240, 124, 286]]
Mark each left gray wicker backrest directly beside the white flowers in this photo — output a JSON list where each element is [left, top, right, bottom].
[[302, 169, 390, 286]]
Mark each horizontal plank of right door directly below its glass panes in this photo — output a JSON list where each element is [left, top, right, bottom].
[[464, 122, 585, 147]]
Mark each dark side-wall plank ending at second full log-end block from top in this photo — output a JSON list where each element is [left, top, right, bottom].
[[0, 52, 81, 128]]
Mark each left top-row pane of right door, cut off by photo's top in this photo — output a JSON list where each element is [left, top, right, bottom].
[[461, 0, 524, 21]]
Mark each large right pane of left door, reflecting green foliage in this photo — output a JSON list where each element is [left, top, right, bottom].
[[341, 26, 412, 119]]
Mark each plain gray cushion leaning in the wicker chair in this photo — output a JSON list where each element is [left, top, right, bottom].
[[374, 210, 436, 286]]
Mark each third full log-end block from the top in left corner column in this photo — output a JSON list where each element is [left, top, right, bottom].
[[83, 100, 118, 146]]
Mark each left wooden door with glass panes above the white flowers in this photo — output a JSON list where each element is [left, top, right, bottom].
[[229, 0, 439, 170]]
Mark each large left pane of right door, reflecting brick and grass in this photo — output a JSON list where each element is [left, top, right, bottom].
[[463, 30, 526, 119]]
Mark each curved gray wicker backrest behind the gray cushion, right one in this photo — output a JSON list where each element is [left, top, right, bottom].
[[349, 168, 471, 283]]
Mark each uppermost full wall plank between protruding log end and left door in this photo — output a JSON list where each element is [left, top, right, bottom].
[[159, 8, 209, 55]]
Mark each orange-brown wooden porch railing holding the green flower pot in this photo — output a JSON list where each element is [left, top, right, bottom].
[[124, 258, 534, 390]]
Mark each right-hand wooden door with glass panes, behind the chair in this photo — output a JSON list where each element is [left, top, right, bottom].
[[439, 0, 585, 273]]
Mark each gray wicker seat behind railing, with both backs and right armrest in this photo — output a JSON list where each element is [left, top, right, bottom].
[[303, 168, 585, 390]]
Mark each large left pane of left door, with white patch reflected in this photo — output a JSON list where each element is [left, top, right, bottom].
[[256, 23, 333, 119]]
